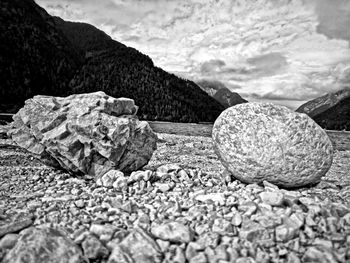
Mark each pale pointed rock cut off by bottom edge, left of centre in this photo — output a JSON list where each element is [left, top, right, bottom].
[[107, 229, 162, 263]]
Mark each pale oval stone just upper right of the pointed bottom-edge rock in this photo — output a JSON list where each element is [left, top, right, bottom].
[[151, 222, 193, 243]]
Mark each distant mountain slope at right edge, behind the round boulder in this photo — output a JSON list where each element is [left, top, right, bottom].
[[296, 88, 350, 131]]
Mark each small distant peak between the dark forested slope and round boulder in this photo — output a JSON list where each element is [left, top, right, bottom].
[[197, 80, 248, 108]]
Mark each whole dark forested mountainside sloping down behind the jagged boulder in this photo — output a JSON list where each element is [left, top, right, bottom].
[[0, 0, 224, 122]]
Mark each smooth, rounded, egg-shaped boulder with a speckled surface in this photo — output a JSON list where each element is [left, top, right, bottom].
[[212, 103, 333, 188]]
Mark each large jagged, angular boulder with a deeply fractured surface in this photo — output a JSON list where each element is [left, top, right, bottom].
[[9, 92, 157, 177]]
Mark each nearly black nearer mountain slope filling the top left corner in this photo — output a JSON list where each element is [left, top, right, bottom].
[[0, 0, 82, 112]]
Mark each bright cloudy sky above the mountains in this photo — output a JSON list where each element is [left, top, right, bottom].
[[36, 0, 350, 109]]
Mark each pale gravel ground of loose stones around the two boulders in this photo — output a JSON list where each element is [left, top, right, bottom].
[[0, 134, 350, 263]]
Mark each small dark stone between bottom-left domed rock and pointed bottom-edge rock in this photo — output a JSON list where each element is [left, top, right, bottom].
[[81, 235, 109, 260]]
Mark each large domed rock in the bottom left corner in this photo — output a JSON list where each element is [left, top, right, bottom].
[[2, 227, 86, 263]]
